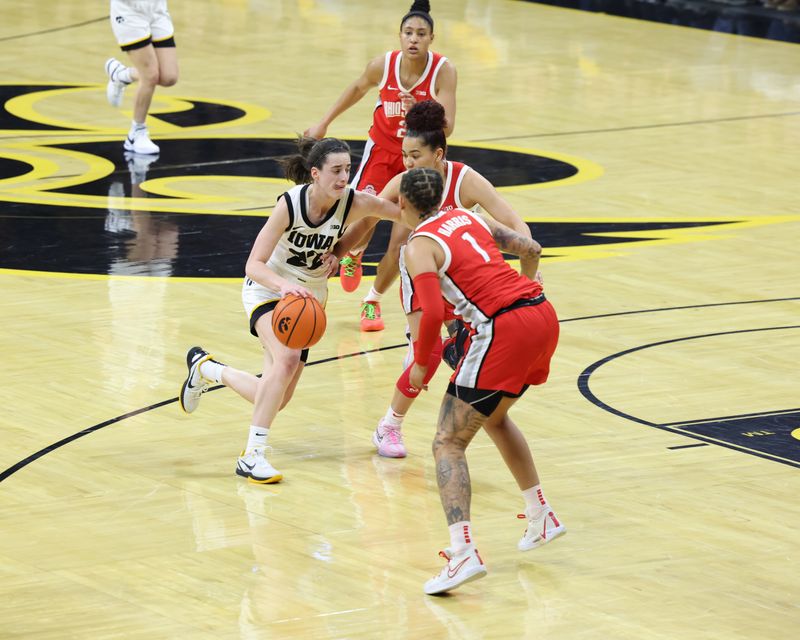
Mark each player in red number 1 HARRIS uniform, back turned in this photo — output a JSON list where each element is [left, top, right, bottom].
[[400, 169, 566, 594]]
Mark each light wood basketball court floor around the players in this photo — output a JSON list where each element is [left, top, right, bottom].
[[0, 0, 800, 640]]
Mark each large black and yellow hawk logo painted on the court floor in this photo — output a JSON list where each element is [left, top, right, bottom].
[[0, 85, 748, 278]]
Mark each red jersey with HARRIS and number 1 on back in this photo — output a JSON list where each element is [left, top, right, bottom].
[[409, 209, 542, 326]]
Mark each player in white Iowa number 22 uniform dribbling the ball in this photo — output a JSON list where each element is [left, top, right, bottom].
[[180, 138, 399, 484]]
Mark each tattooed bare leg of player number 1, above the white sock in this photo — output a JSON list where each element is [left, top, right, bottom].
[[433, 394, 486, 525]]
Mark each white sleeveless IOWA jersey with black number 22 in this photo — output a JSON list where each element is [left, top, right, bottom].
[[267, 184, 355, 286]]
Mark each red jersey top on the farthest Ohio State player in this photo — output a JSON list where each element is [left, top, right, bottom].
[[369, 51, 447, 154]]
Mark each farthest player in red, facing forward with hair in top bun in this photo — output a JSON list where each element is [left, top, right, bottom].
[[305, 0, 456, 298]]
